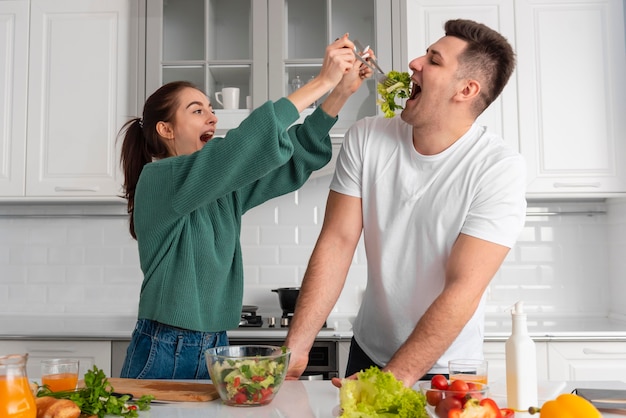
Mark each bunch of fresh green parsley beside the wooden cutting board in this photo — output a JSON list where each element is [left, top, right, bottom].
[[37, 366, 154, 418]]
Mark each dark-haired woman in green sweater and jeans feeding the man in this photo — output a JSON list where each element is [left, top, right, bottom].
[[121, 35, 371, 379]]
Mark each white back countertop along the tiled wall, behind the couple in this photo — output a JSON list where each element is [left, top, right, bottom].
[[0, 314, 626, 341]]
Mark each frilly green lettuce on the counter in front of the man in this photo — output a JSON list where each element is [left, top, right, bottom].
[[339, 367, 428, 418]]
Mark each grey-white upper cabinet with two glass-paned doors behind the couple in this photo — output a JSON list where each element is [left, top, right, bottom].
[[146, 0, 392, 134]]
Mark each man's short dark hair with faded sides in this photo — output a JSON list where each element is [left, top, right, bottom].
[[444, 19, 515, 114]]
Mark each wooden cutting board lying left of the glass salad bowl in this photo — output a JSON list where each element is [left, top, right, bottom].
[[107, 377, 220, 402]]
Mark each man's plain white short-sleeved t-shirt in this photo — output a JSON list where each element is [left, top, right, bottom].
[[330, 117, 526, 373]]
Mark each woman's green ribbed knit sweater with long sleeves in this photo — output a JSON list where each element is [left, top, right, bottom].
[[134, 99, 337, 332]]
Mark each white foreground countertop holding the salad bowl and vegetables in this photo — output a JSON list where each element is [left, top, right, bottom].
[[140, 380, 626, 418]]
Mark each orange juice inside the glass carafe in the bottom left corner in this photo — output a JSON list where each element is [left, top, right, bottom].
[[0, 375, 37, 418]]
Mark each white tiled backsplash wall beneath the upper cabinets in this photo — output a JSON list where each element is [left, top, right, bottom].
[[0, 176, 626, 317]]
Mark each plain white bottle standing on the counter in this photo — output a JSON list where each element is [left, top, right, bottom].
[[504, 301, 537, 411]]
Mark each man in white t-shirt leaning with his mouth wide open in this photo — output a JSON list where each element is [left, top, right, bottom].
[[286, 20, 526, 386]]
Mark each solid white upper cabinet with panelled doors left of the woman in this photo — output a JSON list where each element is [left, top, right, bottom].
[[0, 0, 141, 199]]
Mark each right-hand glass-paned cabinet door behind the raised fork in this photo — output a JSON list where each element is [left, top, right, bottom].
[[268, 0, 391, 130]]
